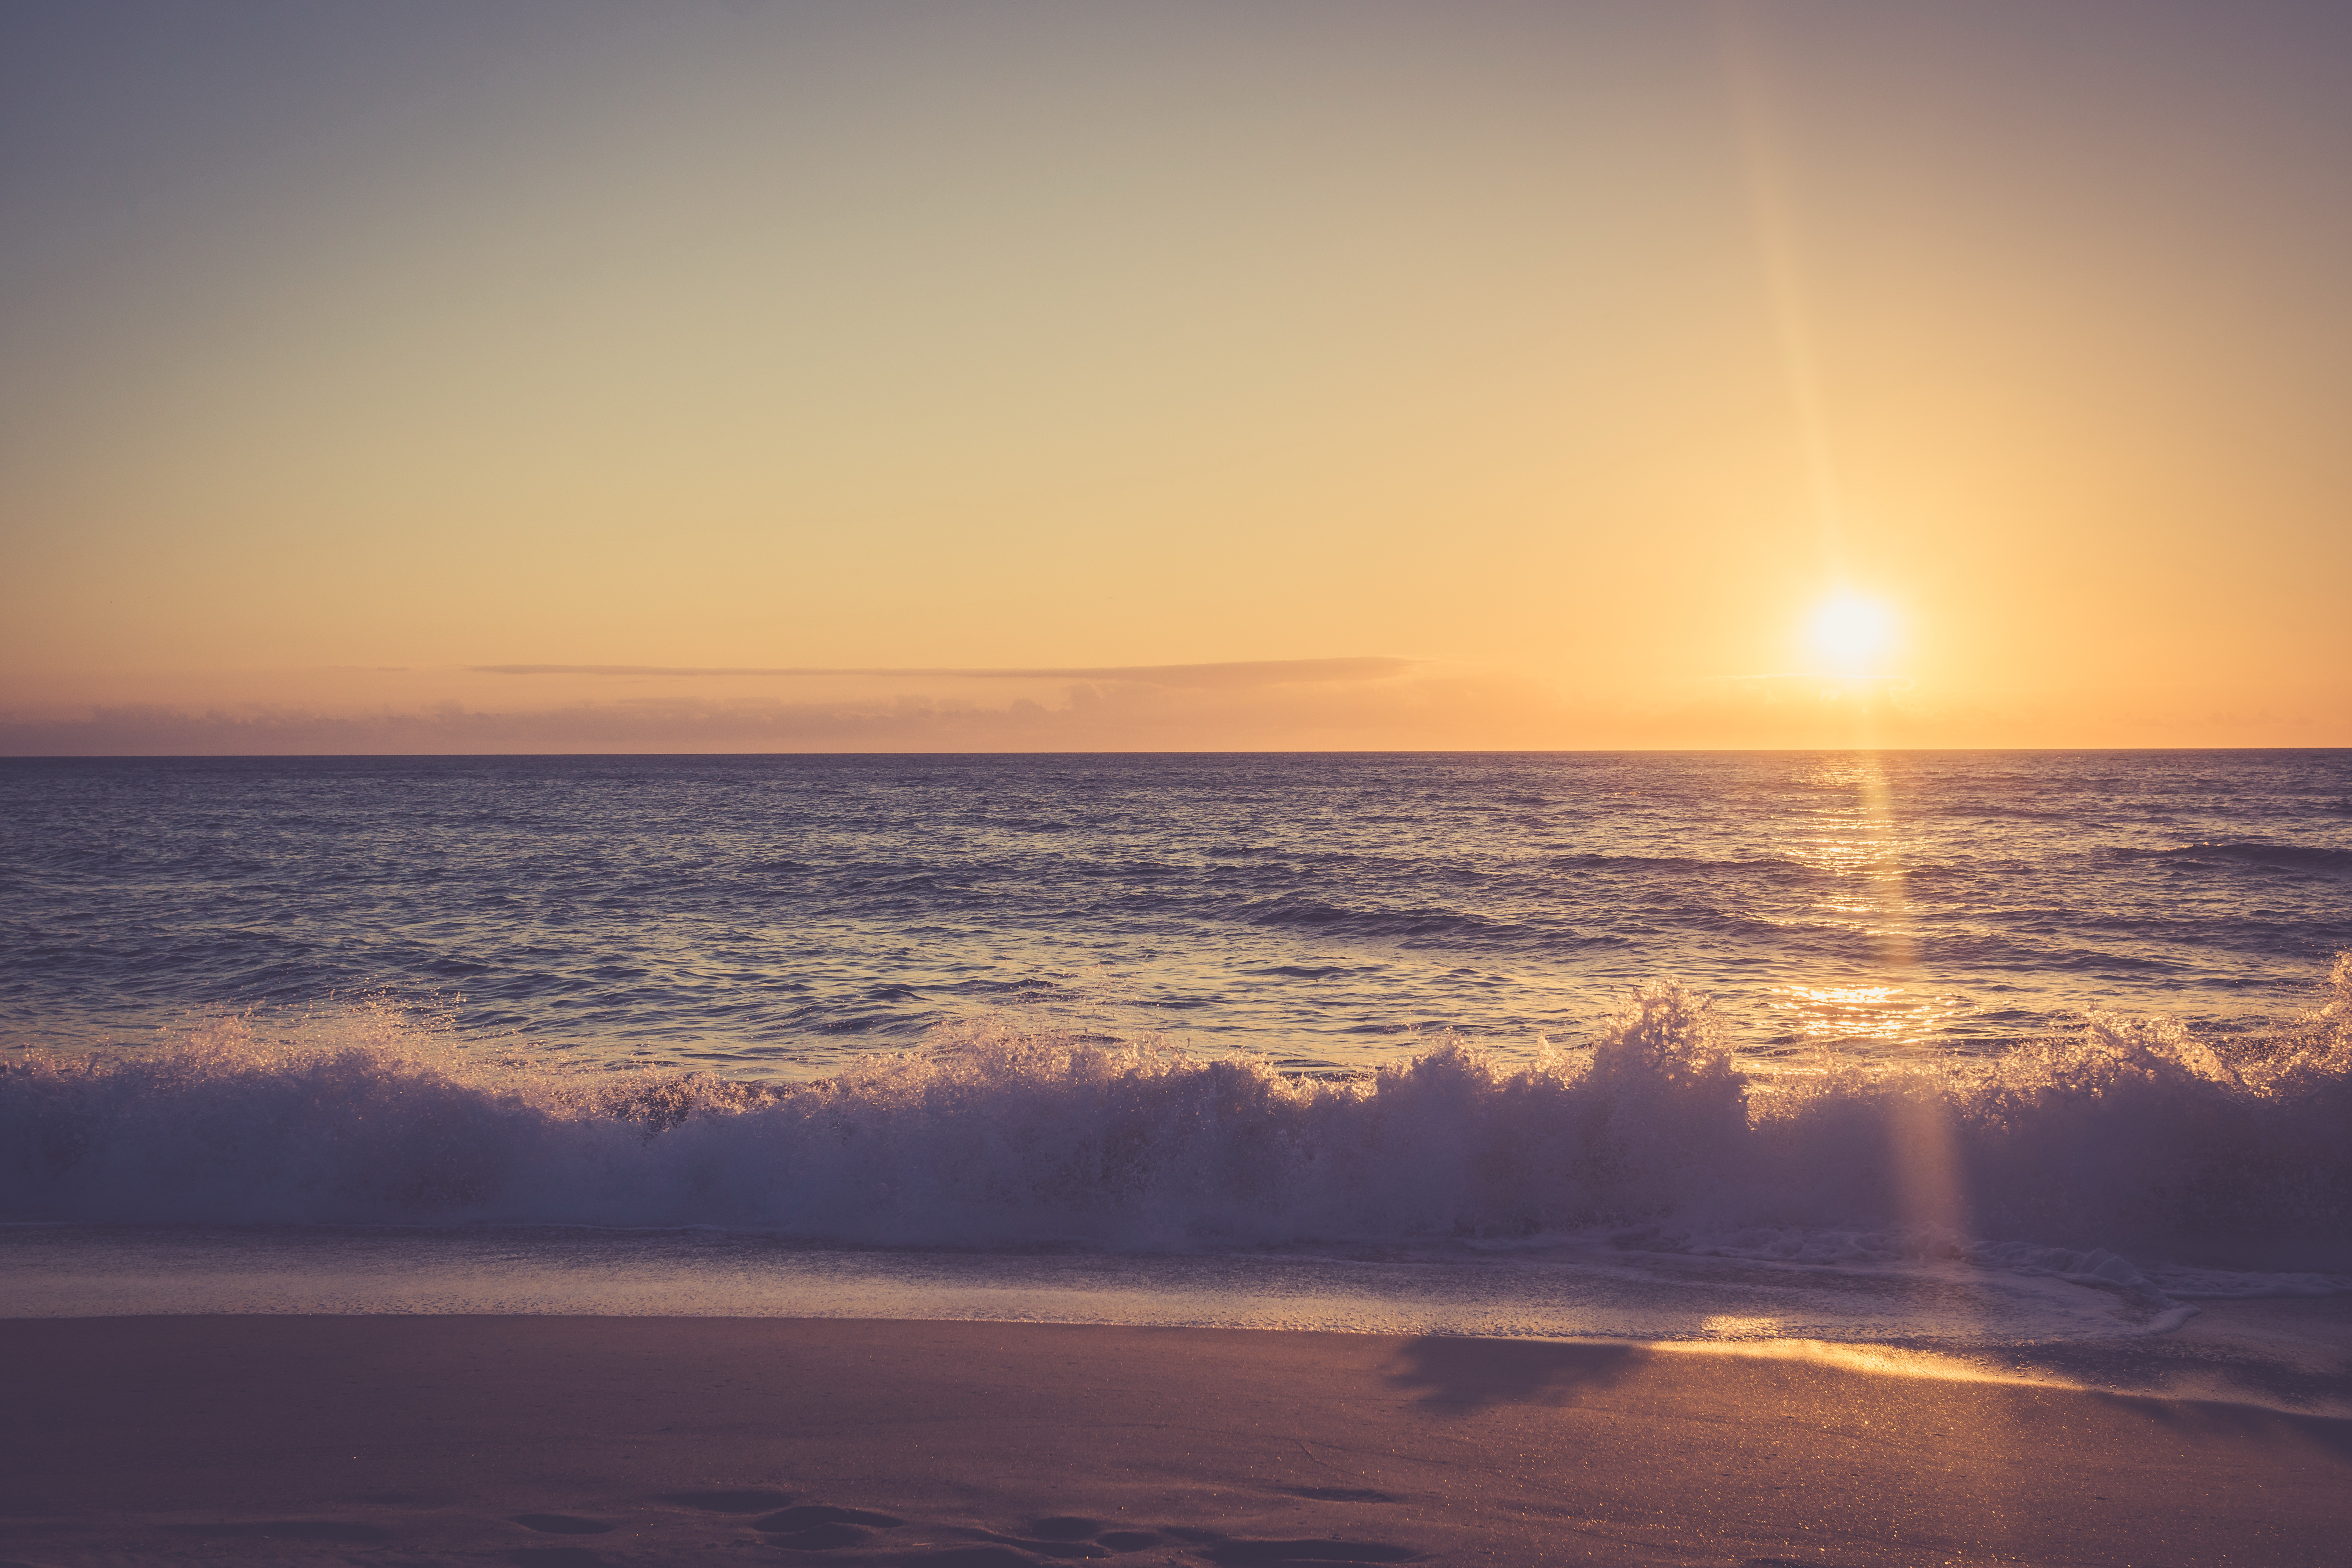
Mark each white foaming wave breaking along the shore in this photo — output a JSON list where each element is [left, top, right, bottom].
[[0, 955, 2352, 1283]]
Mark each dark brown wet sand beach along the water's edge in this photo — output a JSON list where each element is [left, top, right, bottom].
[[0, 1316, 2352, 1568]]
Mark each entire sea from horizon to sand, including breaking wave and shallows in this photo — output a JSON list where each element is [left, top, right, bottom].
[[0, 750, 2352, 1392]]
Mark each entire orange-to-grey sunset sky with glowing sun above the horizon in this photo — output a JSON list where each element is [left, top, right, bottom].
[[0, 0, 2352, 755]]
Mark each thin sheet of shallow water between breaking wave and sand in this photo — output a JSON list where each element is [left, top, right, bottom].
[[0, 1225, 2190, 1349]]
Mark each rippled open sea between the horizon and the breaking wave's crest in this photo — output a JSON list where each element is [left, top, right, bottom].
[[0, 750, 2352, 1079]]
